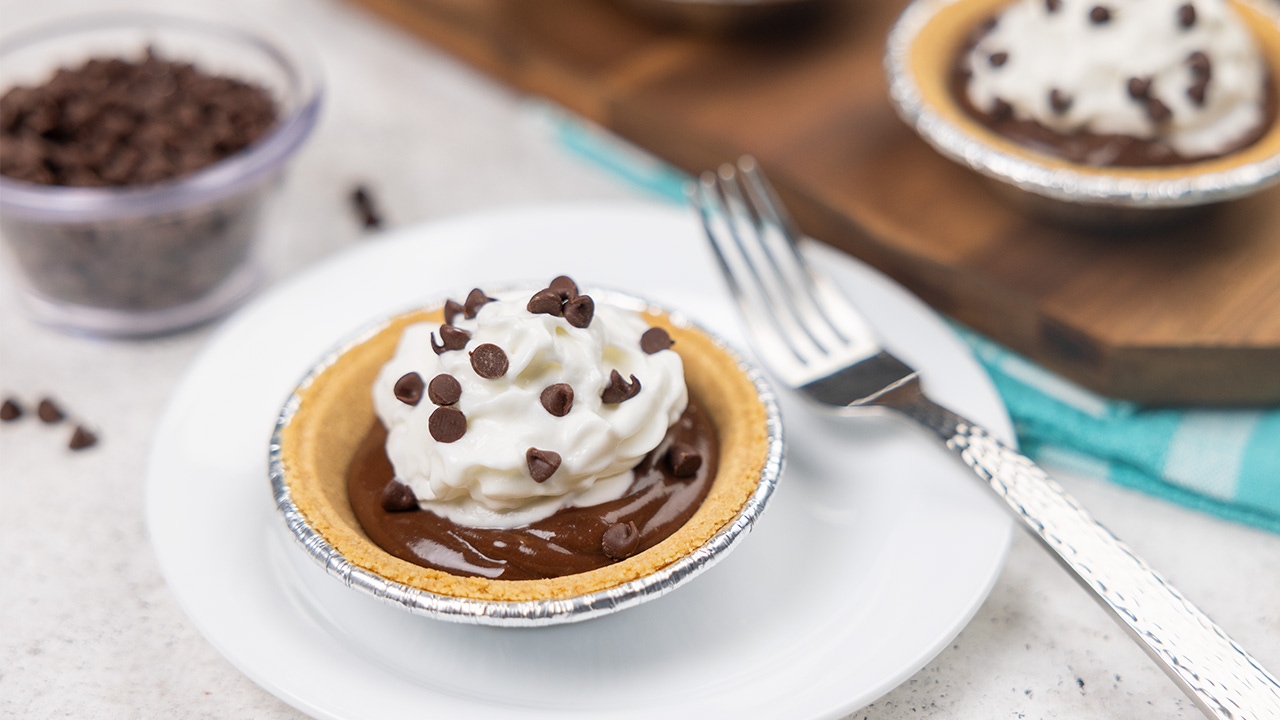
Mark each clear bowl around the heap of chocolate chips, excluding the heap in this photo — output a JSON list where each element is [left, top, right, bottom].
[[0, 14, 321, 337]]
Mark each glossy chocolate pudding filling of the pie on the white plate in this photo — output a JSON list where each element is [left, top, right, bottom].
[[347, 396, 718, 580]]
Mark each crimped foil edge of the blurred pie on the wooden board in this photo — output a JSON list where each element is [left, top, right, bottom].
[[884, 0, 1280, 209]]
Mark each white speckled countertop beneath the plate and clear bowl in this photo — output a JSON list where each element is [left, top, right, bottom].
[[0, 0, 1280, 720]]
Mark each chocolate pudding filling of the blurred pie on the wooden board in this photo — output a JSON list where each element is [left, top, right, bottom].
[[948, 18, 1280, 168]]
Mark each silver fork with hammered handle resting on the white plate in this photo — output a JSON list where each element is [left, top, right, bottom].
[[687, 156, 1280, 720]]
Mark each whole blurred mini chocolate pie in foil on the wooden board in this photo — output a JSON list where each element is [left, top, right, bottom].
[[886, 0, 1280, 219]]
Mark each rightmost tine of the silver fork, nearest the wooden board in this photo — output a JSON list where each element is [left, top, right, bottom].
[[737, 155, 873, 345]]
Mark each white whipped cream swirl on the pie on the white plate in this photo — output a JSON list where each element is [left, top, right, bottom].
[[372, 285, 689, 528]]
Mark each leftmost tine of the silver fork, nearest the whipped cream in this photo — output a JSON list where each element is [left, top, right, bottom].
[[685, 172, 804, 374]]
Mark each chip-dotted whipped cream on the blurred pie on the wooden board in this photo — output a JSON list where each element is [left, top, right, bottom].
[[966, 0, 1266, 158]]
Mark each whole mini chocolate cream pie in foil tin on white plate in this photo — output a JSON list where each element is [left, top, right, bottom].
[[270, 275, 782, 626]]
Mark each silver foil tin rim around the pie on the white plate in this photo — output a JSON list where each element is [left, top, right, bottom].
[[269, 290, 783, 626]]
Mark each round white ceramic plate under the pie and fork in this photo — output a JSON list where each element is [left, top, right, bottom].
[[147, 205, 1012, 719]]
